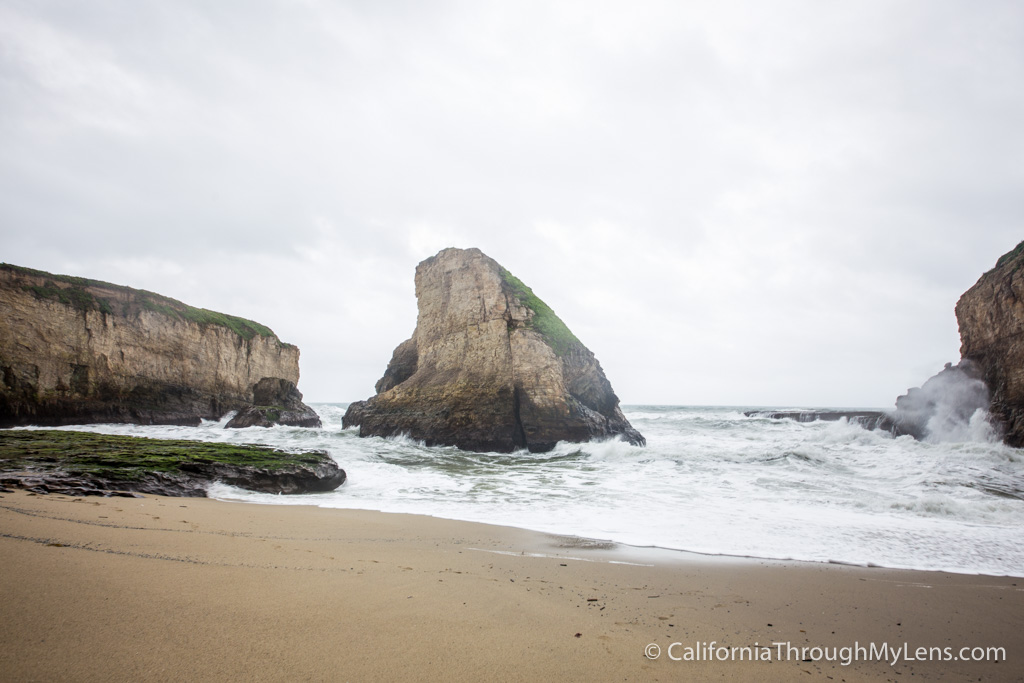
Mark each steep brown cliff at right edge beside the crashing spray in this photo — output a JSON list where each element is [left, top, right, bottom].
[[956, 242, 1024, 447]]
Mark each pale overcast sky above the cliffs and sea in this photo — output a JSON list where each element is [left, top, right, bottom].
[[0, 0, 1024, 407]]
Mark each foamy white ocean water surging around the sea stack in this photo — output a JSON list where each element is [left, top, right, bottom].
[[44, 403, 1024, 577]]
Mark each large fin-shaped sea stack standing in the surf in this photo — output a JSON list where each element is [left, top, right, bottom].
[[344, 249, 645, 453]]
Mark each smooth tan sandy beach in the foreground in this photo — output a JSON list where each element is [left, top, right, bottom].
[[0, 492, 1024, 681]]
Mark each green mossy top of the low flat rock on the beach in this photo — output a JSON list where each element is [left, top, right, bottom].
[[0, 429, 329, 481]]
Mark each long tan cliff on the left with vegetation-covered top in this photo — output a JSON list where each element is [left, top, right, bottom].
[[0, 264, 315, 426]]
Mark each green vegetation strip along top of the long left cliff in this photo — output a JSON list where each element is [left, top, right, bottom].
[[0, 263, 288, 346]]
